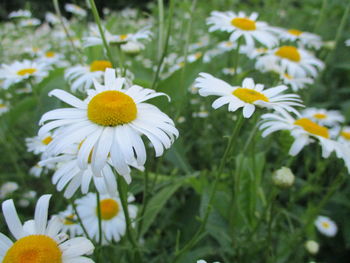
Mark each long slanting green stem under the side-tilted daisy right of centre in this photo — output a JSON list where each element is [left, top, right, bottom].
[[174, 115, 243, 262]]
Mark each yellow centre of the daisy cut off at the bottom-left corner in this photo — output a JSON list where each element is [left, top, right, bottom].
[[2, 235, 62, 263]]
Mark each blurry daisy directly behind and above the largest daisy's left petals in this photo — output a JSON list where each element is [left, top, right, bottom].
[[64, 60, 113, 92]]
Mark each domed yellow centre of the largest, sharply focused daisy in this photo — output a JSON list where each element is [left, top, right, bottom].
[[87, 90, 137, 126]]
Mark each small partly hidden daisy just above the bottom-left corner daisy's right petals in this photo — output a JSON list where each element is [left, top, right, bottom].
[[57, 205, 84, 237]]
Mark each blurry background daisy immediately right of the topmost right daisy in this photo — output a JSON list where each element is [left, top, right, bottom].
[[280, 29, 323, 49]]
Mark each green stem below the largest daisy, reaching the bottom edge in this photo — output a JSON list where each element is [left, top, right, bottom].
[[117, 175, 142, 262]]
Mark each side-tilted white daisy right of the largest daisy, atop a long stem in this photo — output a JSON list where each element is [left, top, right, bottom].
[[195, 73, 303, 118]]
